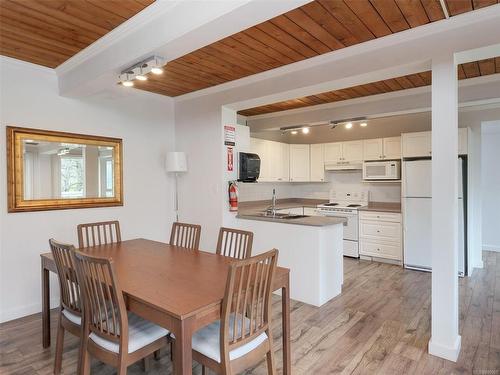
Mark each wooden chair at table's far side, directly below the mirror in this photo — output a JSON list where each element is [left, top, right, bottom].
[[77, 220, 122, 249]]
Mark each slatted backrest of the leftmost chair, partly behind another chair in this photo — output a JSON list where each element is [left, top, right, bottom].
[[49, 239, 82, 316]]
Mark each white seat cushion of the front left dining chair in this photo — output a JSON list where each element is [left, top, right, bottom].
[[89, 312, 169, 353]]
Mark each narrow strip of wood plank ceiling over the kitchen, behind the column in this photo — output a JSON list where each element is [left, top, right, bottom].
[[238, 57, 500, 116]]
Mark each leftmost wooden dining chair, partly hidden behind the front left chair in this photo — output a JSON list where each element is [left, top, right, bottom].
[[49, 238, 82, 374]]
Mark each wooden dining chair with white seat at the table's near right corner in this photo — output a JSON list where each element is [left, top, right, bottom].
[[192, 249, 278, 374]]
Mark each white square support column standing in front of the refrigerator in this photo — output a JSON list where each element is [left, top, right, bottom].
[[429, 53, 461, 361]]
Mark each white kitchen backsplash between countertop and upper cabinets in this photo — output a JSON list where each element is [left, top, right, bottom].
[[238, 171, 401, 202]]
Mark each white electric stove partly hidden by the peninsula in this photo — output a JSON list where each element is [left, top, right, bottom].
[[317, 189, 369, 258]]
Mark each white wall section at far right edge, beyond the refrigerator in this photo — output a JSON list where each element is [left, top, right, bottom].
[[481, 121, 500, 251]]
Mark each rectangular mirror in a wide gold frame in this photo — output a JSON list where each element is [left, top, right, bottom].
[[7, 126, 123, 212]]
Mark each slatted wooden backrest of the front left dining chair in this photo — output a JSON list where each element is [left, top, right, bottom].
[[74, 252, 128, 342]]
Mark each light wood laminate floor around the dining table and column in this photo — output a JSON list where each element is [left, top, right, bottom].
[[0, 252, 500, 375]]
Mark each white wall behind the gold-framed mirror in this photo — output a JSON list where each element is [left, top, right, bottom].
[[0, 58, 175, 321]]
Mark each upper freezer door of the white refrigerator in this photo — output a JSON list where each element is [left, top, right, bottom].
[[403, 160, 432, 198]]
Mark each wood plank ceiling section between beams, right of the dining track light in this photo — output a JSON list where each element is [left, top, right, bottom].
[[135, 0, 498, 96]]
